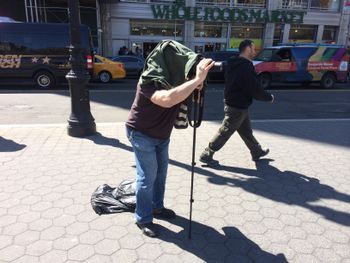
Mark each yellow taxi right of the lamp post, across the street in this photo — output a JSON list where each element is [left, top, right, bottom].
[[94, 55, 126, 83]]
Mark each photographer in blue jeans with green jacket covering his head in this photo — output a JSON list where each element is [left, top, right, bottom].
[[126, 40, 214, 237]]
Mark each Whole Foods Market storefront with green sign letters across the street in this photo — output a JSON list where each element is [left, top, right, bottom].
[[100, 0, 350, 56]]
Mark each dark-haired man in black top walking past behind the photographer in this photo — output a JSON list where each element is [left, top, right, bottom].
[[199, 39, 274, 166]]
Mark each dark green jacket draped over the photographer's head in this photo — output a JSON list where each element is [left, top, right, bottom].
[[139, 40, 200, 89]]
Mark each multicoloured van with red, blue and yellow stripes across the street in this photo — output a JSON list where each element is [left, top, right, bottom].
[[253, 44, 349, 89]]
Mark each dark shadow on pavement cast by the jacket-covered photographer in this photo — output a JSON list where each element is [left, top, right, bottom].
[[157, 216, 288, 263]]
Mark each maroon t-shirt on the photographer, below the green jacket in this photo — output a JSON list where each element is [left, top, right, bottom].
[[126, 84, 180, 139]]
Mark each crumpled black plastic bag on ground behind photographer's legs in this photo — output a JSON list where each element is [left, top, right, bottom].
[[91, 180, 136, 215]]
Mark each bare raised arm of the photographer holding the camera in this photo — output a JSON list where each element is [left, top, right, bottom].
[[151, 59, 214, 108]]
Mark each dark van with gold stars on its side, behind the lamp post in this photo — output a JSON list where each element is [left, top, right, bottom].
[[0, 22, 93, 89]]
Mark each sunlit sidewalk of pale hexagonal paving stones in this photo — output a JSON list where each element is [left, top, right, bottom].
[[0, 120, 350, 263]]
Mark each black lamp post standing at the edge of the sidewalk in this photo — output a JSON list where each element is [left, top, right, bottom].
[[66, 0, 96, 137]]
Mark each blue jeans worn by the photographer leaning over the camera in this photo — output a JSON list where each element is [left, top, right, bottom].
[[126, 127, 170, 224]]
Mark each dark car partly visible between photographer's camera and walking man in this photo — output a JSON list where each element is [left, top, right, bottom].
[[203, 50, 239, 81]]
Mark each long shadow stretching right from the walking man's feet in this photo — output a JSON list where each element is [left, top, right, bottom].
[[202, 159, 350, 226]]
